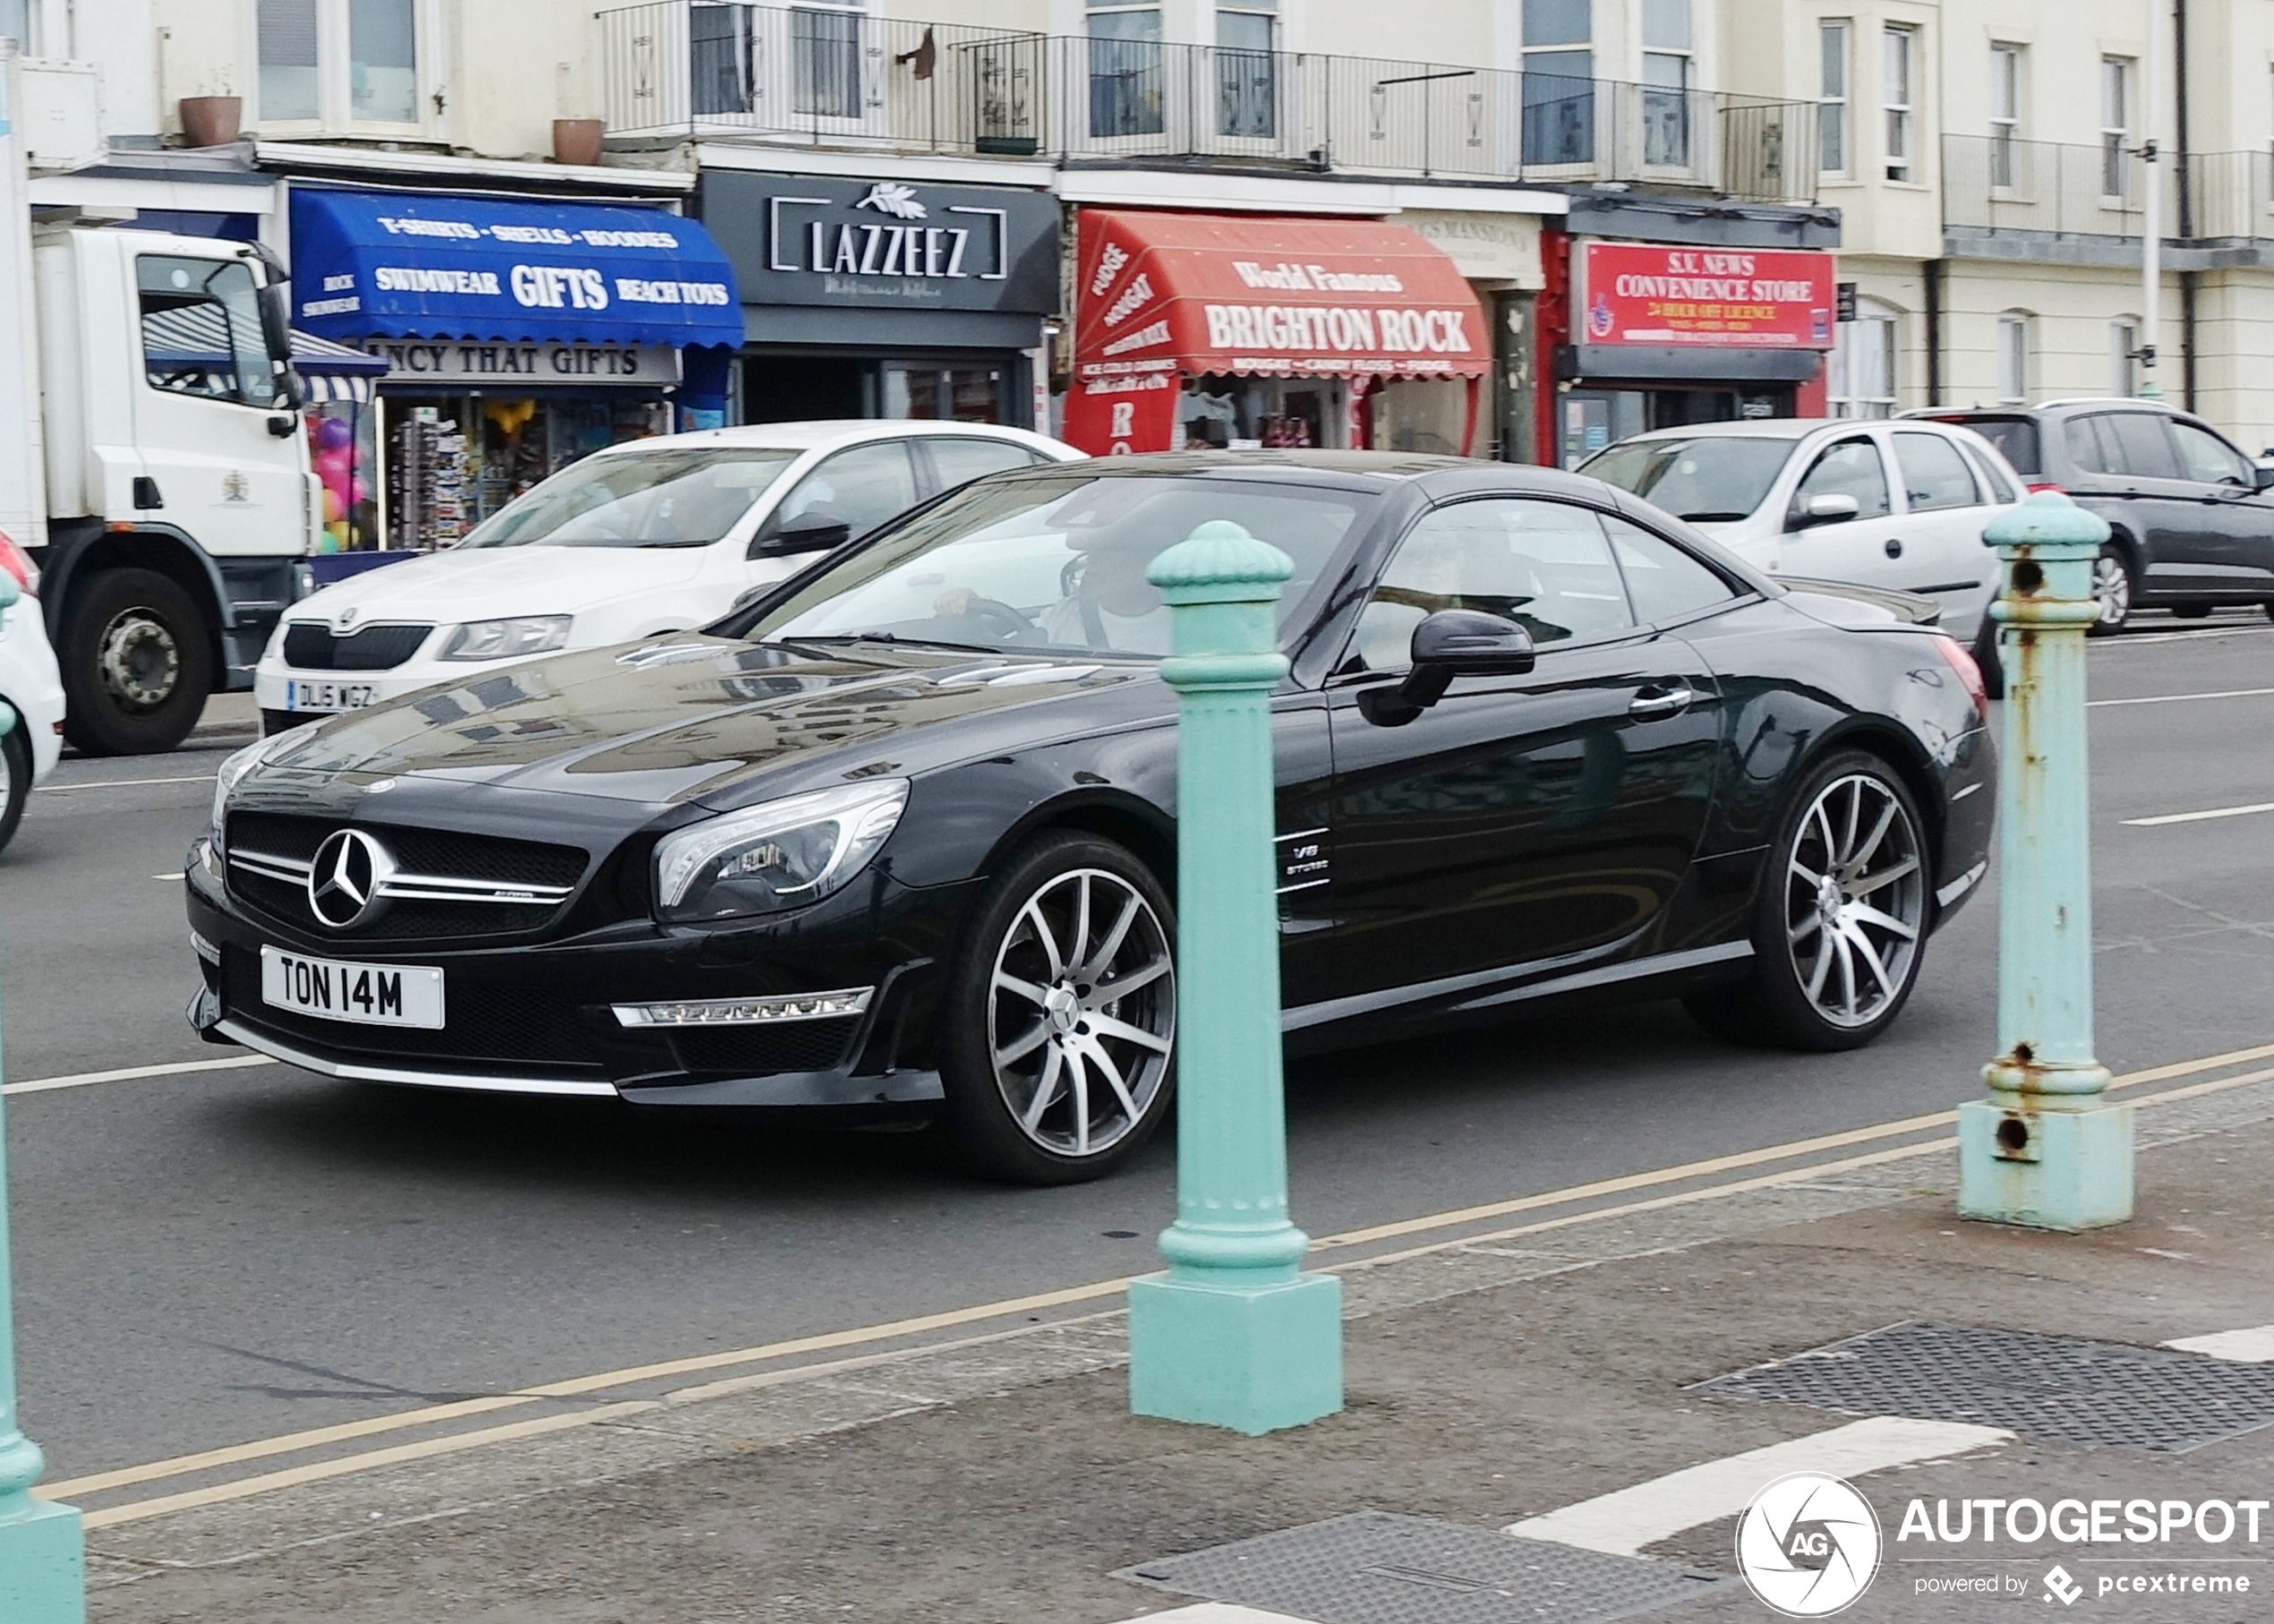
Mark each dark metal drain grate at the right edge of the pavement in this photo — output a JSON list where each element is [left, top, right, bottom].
[[1692, 1320, 2274, 1453]]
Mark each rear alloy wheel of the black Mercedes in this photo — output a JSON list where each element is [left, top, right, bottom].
[[1785, 774, 1926, 1028]]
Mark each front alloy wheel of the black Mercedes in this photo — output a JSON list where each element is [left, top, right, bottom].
[[987, 869, 1175, 1158]]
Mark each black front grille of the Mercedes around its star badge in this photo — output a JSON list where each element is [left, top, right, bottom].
[[227, 812, 591, 942]]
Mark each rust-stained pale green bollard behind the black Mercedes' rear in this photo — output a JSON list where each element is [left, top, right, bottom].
[[1958, 491, 2133, 1230]]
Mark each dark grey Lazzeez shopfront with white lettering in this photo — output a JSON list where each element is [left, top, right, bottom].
[[703, 168, 1057, 430]]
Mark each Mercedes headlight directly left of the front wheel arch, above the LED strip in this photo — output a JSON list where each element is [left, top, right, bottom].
[[655, 778, 907, 919]]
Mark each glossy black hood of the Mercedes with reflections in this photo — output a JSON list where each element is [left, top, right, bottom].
[[257, 635, 1175, 805]]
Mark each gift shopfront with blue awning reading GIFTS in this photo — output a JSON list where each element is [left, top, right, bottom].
[[291, 186, 741, 551]]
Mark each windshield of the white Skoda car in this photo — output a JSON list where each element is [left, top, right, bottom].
[[459, 446, 799, 546]]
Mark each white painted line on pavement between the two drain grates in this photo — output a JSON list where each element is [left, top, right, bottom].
[[1505, 1415, 2013, 1556]]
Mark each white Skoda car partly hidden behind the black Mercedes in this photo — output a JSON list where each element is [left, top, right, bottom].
[[254, 421, 1082, 732]]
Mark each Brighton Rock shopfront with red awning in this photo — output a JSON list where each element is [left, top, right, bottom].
[[1064, 209, 1492, 455]]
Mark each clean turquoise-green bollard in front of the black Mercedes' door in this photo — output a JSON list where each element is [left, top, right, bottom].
[[1130, 521, 1342, 1438]]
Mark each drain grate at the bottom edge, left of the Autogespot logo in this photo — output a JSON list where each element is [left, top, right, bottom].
[[1115, 1510, 1714, 1624]]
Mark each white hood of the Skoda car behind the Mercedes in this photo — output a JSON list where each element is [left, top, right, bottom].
[[285, 546, 705, 628]]
